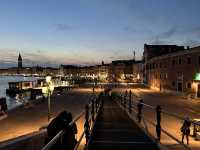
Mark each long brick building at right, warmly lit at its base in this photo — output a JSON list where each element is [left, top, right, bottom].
[[144, 44, 200, 97]]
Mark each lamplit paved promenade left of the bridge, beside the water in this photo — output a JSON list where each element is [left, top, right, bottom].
[[0, 88, 92, 144]]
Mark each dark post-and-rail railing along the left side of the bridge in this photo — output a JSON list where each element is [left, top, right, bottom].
[[42, 93, 102, 150]]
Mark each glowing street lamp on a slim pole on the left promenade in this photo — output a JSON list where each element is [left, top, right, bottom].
[[42, 76, 54, 121]]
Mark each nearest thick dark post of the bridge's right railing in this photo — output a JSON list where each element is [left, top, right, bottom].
[[156, 105, 161, 141]]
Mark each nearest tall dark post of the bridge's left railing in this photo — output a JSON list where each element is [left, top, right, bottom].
[[84, 105, 90, 146]]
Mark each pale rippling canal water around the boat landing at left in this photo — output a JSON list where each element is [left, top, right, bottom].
[[0, 75, 38, 110]]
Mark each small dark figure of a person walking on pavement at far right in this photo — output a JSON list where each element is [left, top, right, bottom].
[[181, 117, 191, 144]]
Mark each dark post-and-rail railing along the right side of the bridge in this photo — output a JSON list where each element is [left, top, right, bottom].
[[113, 91, 195, 149]]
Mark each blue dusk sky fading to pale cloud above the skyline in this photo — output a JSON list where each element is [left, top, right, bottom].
[[0, 0, 200, 68]]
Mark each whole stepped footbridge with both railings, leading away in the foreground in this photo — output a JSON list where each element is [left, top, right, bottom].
[[0, 91, 192, 150]]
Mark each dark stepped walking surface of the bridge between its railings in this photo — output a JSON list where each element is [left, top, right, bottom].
[[89, 95, 158, 150]]
